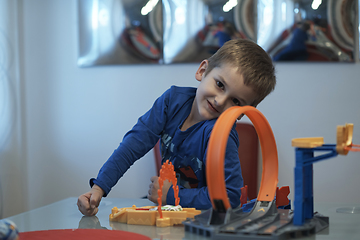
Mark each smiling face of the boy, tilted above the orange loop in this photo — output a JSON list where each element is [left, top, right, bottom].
[[193, 60, 257, 121]]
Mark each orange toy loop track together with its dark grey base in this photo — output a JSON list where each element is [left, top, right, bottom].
[[183, 106, 328, 240]]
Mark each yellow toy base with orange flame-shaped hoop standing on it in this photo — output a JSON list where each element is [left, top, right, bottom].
[[109, 160, 201, 227]]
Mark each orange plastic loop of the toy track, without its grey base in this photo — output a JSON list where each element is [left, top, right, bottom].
[[206, 106, 278, 211]]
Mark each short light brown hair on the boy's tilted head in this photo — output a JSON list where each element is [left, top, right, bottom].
[[205, 39, 276, 106]]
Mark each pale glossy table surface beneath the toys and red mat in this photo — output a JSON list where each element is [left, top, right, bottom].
[[4, 197, 360, 240]]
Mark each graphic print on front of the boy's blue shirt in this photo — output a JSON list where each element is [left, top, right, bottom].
[[161, 134, 203, 188]]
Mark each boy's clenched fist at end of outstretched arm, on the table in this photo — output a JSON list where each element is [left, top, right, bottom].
[[77, 184, 104, 216]]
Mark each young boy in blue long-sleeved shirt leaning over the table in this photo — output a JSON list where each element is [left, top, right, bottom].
[[78, 39, 276, 216]]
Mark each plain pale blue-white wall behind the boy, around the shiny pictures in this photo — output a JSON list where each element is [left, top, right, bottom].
[[0, 0, 360, 217]]
